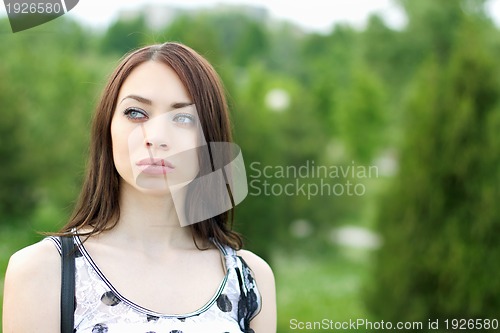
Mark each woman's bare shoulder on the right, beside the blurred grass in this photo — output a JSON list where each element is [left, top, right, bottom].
[[238, 250, 277, 333]]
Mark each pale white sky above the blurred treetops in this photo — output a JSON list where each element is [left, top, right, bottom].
[[0, 0, 500, 32]]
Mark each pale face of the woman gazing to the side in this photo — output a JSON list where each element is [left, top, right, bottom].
[[111, 61, 205, 194]]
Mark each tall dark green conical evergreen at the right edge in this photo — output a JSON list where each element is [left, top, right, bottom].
[[372, 11, 500, 322]]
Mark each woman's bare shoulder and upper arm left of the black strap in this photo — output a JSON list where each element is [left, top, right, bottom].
[[3, 241, 61, 333]]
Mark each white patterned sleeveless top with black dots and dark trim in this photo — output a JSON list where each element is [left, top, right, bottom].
[[46, 236, 262, 333]]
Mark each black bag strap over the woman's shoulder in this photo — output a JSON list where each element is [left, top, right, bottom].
[[61, 237, 75, 333]]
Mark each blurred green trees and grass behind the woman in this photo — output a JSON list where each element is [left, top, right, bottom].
[[0, 0, 500, 333]]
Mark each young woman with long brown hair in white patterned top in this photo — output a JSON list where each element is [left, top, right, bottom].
[[3, 43, 276, 333]]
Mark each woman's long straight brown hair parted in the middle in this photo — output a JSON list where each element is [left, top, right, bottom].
[[57, 42, 243, 249]]
